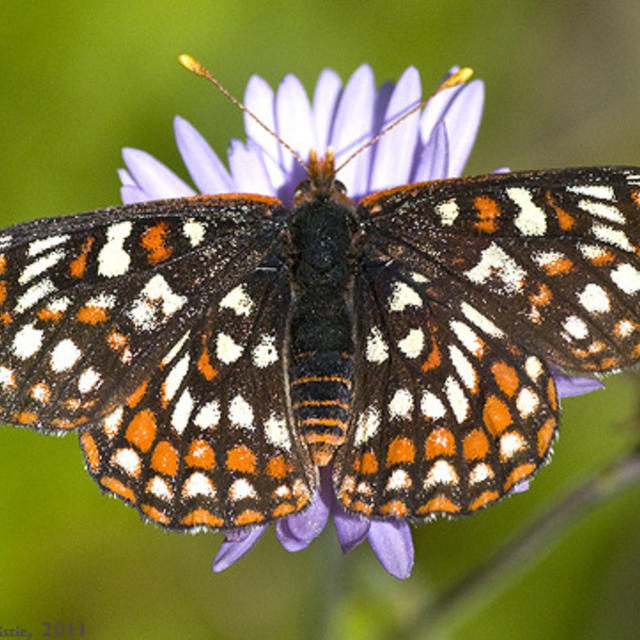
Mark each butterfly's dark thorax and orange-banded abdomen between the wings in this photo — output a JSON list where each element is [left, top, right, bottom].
[[289, 199, 353, 466]]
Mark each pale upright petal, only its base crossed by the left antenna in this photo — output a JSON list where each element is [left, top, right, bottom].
[[276, 74, 317, 172]]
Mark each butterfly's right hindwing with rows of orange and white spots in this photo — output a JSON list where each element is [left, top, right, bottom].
[[335, 262, 558, 520]]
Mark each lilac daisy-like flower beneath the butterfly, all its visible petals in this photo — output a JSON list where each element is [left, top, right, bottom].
[[119, 65, 602, 578]]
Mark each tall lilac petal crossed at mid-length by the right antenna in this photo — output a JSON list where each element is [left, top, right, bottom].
[[368, 67, 422, 191]]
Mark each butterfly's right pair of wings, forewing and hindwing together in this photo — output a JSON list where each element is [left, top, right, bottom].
[[335, 168, 640, 518]]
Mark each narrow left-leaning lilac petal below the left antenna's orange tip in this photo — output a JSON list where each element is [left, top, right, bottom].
[[173, 116, 235, 193]]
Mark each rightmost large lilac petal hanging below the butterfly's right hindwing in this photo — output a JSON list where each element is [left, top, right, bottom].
[[368, 520, 414, 580]]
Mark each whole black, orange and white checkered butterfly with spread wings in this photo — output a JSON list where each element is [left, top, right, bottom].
[[0, 61, 640, 530]]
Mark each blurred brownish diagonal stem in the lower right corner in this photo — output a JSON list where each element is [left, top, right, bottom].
[[393, 446, 640, 640]]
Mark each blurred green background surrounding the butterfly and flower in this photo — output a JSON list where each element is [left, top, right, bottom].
[[0, 0, 640, 640]]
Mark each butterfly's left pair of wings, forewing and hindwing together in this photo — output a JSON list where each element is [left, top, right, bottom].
[[0, 196, 310, 528]]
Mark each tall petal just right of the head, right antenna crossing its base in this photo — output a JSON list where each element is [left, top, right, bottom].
[[329, 65, 375, 198]]
